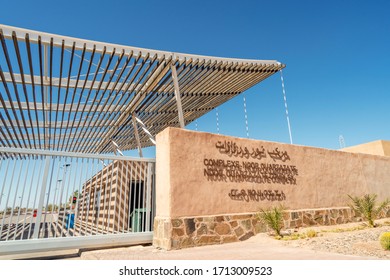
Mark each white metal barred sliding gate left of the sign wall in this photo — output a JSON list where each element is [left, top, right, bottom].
[[0, 147, 155, 255]]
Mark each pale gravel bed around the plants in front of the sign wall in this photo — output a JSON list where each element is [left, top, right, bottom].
[[281, 219, 390, 259]]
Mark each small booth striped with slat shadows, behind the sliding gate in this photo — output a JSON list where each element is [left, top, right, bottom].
[[76, 161, 154, 233]]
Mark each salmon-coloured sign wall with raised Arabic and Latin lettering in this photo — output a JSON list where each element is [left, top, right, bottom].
[[155, 128, 390, 249]]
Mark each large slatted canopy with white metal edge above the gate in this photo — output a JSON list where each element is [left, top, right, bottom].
[[0, 24, 285, 153]]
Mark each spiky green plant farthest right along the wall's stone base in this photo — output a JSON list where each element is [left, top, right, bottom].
[[348, 194, 390, 227]]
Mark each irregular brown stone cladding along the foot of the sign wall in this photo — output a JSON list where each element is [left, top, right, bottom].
[[153, 207, 390, 250]]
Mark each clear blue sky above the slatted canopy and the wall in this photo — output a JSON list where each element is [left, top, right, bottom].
[[0, 0, 390, 155]]
